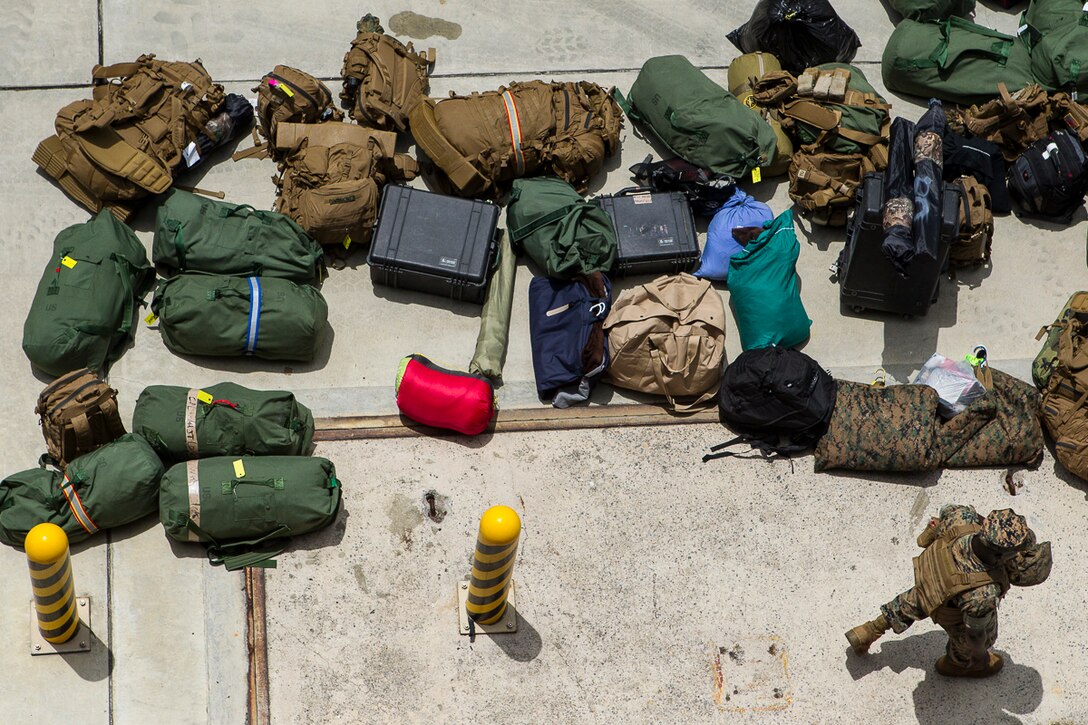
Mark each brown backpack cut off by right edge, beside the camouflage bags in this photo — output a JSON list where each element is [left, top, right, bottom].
[[1042, 316, 1088, 479]]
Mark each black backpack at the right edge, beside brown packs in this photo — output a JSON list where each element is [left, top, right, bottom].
[[1009, 131, 1088, 224]]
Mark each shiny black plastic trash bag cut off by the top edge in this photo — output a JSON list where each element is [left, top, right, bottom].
[[728, 0, 862, 75]]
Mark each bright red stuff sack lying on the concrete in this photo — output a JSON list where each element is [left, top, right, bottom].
[[396, 355, 495, 435]]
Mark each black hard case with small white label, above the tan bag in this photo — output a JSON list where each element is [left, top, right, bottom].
[[594, 187, 698, 277]]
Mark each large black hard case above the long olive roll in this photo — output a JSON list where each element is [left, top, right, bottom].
[[367, 185, 502, 303]]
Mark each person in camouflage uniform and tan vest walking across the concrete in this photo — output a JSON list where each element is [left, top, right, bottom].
[[846, 505, 1052, 677]]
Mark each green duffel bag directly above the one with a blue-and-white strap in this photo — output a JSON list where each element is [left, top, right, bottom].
[[151, 188, 325, 285]]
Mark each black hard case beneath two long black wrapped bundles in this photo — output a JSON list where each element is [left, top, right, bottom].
[[839, 173, 961, 316]]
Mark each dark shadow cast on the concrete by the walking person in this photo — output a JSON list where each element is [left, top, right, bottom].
[[845, 630, 1042, 725]]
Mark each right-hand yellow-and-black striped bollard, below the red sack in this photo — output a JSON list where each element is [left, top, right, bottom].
[[461, 506, 521, 631]]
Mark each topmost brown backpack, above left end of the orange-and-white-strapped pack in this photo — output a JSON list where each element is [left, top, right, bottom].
[[341, 13, 434, 131]]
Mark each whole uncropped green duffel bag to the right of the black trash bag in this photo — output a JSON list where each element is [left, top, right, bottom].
[[880, 17, 1034, 106]]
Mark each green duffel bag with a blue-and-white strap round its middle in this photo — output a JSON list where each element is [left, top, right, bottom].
[[151, 272, 329, 361]]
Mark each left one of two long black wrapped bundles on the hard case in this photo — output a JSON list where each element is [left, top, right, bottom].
[[880, 118, 914, 277]]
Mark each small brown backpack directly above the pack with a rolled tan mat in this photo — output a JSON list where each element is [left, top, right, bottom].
[[244, 65, 344, 159]]
